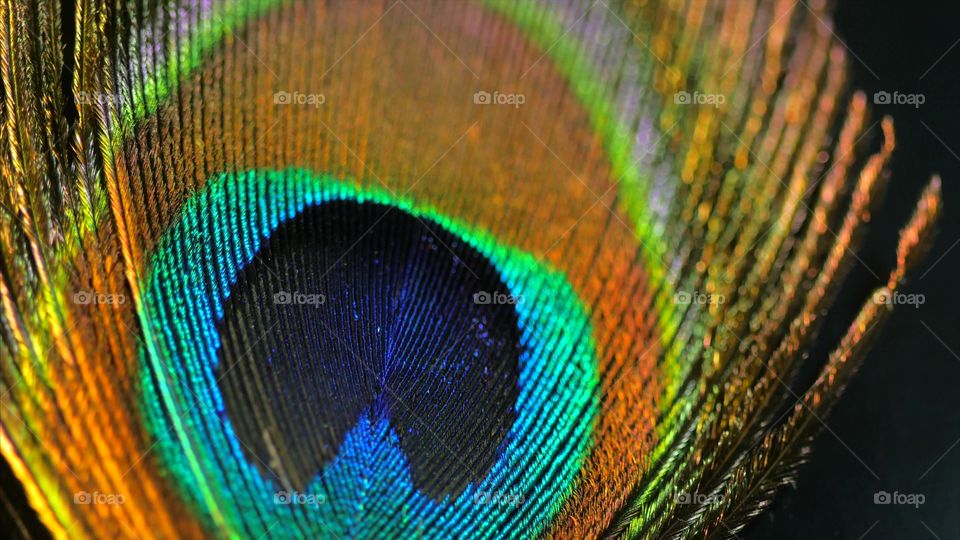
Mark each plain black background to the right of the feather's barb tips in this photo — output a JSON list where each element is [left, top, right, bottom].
[[752, 0, 960, 540]]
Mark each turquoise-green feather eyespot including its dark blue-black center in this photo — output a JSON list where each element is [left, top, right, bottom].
[[141, 170, 597, 537]]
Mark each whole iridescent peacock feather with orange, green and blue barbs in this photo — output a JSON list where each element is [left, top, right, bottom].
[[0, 0, 940, 538]]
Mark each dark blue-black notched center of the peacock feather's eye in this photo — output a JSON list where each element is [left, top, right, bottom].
[[216, 200, 521, 500]]
